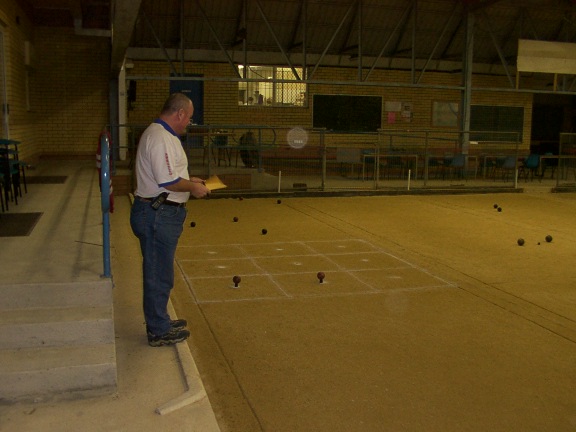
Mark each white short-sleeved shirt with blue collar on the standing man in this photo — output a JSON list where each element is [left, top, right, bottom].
[[134, 119, 190, 203]]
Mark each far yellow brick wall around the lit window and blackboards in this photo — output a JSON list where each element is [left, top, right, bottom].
[[128, 61, 532, 148]]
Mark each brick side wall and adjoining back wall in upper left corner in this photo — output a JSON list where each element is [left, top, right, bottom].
[[0, 0, 110, 162]]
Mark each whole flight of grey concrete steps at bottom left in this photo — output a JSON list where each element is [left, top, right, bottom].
[[0, 281, 117, 403]]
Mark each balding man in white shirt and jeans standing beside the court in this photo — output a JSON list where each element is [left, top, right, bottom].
[[130, 93, 210, 346]]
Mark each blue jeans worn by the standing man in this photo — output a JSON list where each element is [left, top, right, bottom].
[[130, 198, 186, 335]]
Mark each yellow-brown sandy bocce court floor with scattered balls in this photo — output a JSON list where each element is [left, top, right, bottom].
[[112, 190, 576, 431]]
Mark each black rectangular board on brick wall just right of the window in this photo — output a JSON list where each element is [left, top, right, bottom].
[[312, 95, 382, 133]]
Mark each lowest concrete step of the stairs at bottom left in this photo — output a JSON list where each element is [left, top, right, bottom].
[[0, 344, 117, 403]]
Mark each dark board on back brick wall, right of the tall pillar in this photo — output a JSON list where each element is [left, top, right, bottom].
[[470, 105, 524, 141]]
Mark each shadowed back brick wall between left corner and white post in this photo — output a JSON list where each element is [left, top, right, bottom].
[[33, 27, 110, 157]]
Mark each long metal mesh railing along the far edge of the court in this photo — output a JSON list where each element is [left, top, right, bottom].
[[107, 124, 529, 192]]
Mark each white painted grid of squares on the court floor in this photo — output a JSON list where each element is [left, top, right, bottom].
[[176, 239, 455, 303]]
